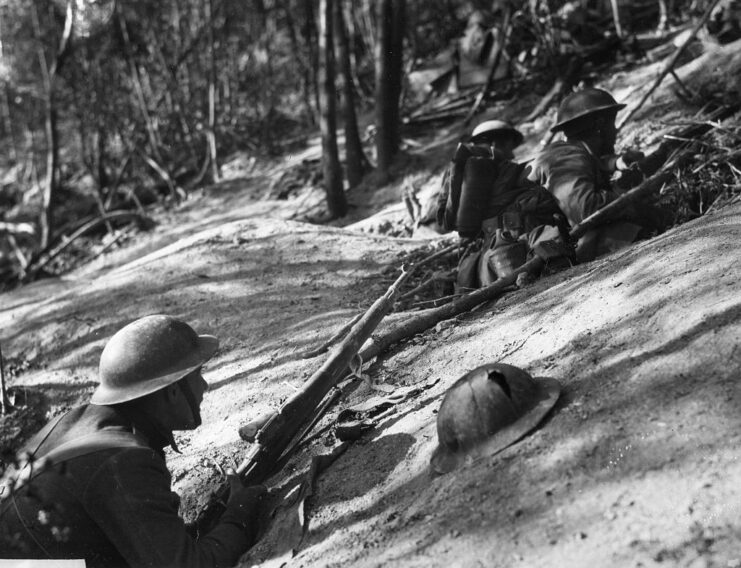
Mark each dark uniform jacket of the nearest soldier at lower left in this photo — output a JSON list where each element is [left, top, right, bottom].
[[0, 405, 257, 568]]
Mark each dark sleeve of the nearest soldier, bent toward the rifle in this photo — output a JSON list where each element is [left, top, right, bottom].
[[83, 449, 256, 568]]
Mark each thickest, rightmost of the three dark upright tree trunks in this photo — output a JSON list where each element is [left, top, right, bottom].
[[375, 0, 405, 175]]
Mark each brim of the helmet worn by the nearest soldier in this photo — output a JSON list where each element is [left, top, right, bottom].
[[90, 335, 219, 405]]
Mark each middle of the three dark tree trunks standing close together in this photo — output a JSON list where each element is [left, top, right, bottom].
[[334, 2, 370, 187]]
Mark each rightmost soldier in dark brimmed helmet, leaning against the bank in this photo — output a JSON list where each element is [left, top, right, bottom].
[[529, 88, 644, 260]]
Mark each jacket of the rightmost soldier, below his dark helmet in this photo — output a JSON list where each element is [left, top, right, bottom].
[[530, 147, 617, 225]]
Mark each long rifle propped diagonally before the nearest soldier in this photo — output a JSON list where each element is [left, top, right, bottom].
[[196, 262, 420, 532]]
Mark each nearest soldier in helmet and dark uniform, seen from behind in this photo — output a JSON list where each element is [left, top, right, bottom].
[[0, 315, 265, 567]]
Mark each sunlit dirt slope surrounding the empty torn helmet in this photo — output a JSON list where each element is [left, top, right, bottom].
[[258, 206, 741, 567]]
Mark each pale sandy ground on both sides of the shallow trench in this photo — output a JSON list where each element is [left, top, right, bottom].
[[0, 35, 741, 568]]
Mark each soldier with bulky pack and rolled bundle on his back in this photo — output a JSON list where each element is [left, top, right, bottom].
[[438, 120, 570, 291]]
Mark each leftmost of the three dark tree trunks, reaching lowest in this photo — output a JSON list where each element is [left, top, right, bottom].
[[319, 0, 347, 218]]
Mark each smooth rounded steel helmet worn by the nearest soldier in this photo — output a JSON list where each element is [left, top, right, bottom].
[[90, 315, 219, 404]]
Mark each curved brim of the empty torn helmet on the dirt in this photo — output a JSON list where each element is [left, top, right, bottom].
[[430, 377, 561, 475]]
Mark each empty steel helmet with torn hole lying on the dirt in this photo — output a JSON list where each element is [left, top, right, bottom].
[[430, 363, 561, 474]]
